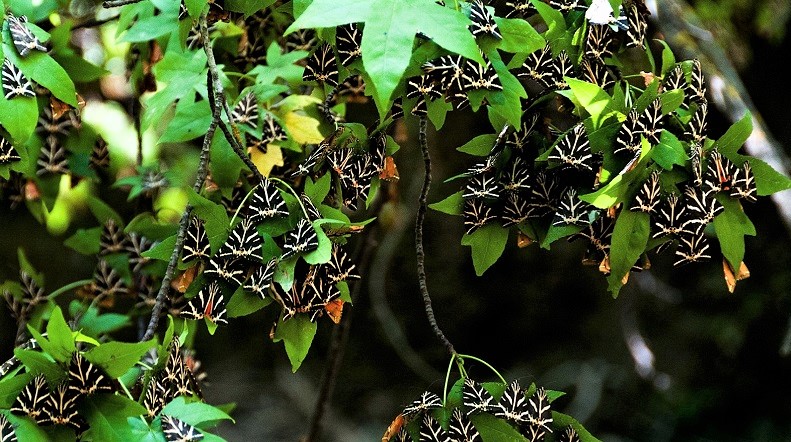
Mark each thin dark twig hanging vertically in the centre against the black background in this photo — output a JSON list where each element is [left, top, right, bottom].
[[415, 116, 456, 357]]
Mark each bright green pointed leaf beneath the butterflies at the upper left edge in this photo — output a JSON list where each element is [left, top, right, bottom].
[[3, 42, 77, 107]]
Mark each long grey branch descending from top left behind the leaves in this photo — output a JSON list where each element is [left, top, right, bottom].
[[140, 13, 222, 341]]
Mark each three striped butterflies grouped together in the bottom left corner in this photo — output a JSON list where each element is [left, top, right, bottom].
[[5, 352, 119, 435]]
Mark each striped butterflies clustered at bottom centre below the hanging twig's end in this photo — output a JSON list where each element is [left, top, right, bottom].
[[390, 378, 580, 442]]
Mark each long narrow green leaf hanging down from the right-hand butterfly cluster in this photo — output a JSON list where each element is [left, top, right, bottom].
[[607, 210, 651, 297]]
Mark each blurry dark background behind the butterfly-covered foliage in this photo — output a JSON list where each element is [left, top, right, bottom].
[[0, 2, 791, 441]]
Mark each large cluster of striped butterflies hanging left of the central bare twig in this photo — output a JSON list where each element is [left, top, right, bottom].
[[180, 176, 359, 324]]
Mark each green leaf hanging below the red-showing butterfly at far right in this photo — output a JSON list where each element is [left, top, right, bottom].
[[714, 194, 756, 269]]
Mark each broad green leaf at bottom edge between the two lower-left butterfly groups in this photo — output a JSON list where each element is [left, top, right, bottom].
[[81, 393, 146, 442]]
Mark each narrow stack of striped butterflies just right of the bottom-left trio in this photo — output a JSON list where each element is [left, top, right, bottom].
[[140, 336, 203, 418]]
